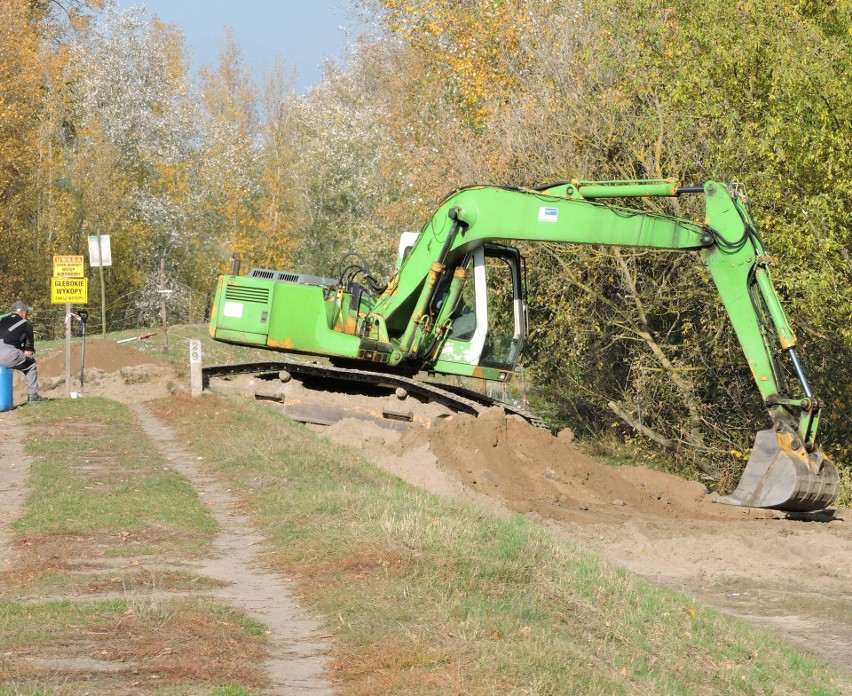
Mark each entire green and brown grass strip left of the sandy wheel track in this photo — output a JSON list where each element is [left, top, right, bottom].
[[0, 399, 265, 696]]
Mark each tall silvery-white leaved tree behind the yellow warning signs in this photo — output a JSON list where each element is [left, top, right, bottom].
[[65, 6, 198, 320]]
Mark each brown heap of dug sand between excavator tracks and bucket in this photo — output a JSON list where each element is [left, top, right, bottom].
[[322, 408, 760, 523]]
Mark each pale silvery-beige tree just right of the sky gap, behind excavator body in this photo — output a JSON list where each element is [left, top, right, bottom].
[[292, 39, 420, 275]]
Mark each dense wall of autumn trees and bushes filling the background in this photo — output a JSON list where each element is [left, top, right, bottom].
[[0, 0, 852, 490]]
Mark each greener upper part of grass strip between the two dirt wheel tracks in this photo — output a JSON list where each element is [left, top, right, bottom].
[[15, 398, 216, 545]]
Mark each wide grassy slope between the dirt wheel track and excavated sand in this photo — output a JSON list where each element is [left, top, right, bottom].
[[150, 397, 846, 696]]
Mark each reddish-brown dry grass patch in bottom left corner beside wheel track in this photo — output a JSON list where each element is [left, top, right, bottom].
[[0, 599, 267, 694]]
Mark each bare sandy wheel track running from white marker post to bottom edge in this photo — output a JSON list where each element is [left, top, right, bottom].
[[130, 403, 334, 696]]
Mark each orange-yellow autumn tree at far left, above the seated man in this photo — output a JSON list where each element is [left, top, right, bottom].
[[0, 0, 103, 308]]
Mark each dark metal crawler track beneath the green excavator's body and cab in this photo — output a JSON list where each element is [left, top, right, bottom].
[[202, 360, 547, 429]]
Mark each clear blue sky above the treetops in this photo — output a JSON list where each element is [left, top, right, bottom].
[[117, 0, 366, 92]]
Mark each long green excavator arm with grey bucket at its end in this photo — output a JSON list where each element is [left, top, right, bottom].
[[370, 181, 839, 510]]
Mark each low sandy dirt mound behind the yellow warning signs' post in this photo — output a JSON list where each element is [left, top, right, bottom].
[[15, 339, 188, 403]]
